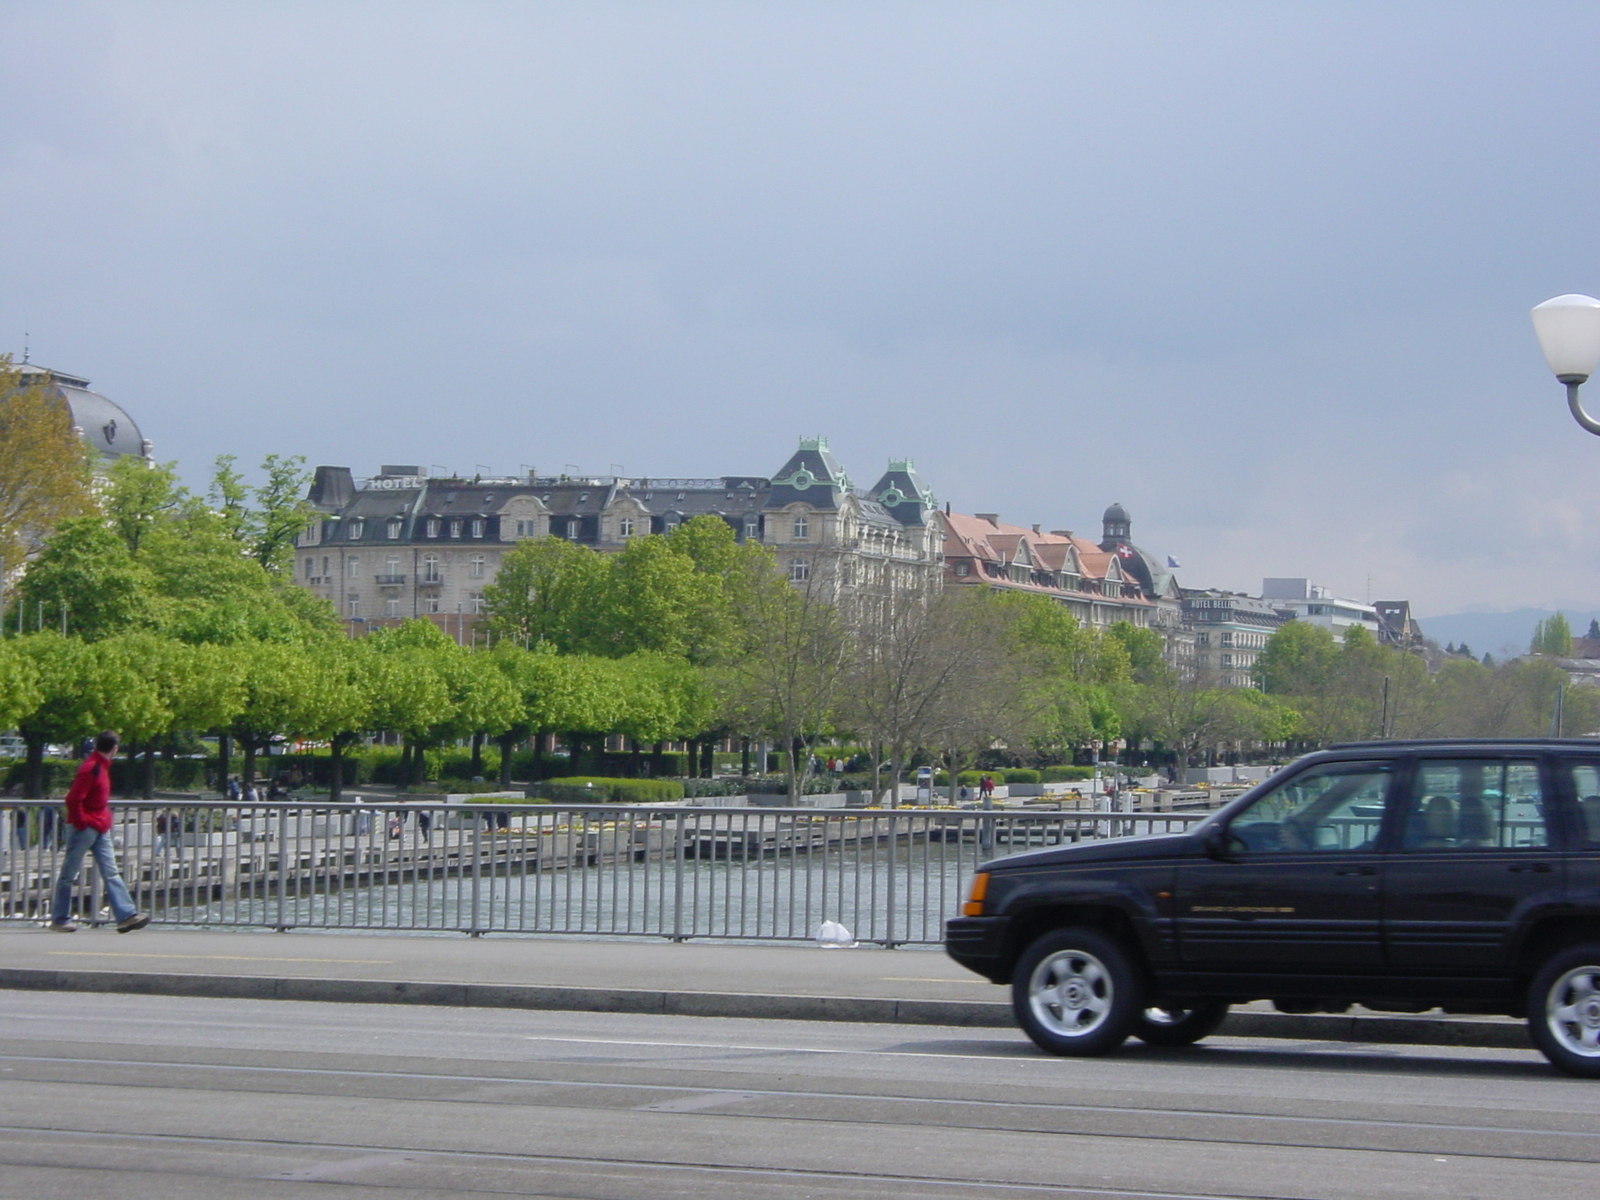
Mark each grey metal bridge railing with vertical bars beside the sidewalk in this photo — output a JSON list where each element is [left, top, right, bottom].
[[0, 802, 1205, 946]]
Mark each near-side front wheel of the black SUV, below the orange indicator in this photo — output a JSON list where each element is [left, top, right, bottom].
[[1011, 928, 1144, 1054]]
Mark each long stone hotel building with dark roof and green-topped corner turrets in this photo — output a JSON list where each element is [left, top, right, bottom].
[[294, 438, 941, 640]]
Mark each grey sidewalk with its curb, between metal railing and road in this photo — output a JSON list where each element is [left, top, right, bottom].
[[0, 922, 1531, 1050]]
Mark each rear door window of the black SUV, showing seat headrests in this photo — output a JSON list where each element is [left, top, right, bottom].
[[1400, 758, 1550, 851]]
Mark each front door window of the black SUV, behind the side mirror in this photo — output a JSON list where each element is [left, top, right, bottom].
[[1227, 763, 1392, 854]]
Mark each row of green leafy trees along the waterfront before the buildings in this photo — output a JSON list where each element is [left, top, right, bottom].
[[0, 395, 1600, 795]]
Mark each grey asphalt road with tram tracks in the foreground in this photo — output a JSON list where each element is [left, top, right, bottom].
[[0, 992, 1600, 1200]]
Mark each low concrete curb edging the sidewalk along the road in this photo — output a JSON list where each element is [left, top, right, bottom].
[[0, 966, 1533, 1050]]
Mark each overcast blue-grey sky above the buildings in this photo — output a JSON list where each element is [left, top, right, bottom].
[[0, 0, 1600, 614]]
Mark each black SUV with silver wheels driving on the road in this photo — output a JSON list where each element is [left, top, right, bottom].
[[944, 739, 1600, 1078]]
